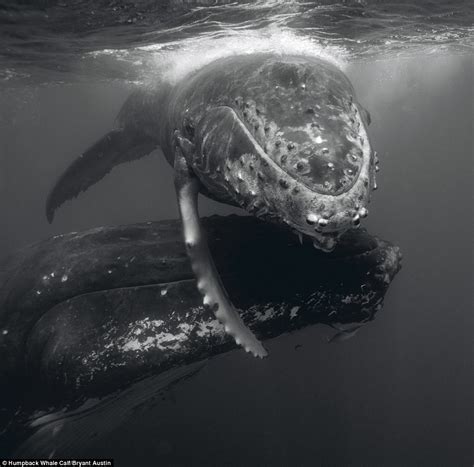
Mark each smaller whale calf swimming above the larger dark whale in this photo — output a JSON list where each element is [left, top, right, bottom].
[[46, 54, 377, 357]]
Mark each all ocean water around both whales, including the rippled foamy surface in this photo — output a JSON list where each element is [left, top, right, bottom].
[[0, 0, 474, 467]]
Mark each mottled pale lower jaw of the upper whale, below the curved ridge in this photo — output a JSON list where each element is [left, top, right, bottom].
[[194, 107, 375, 251]]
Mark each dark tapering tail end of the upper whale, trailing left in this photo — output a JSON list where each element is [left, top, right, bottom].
[[46, 90, 163, 227]]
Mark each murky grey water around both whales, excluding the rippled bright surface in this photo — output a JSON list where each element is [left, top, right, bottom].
[[0, 55, 474, 466]]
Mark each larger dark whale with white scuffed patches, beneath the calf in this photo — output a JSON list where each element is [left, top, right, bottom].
[[0, 215, 401, 458]]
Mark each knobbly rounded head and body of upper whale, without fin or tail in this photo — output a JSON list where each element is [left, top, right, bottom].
[[165, 55, 375, 250]]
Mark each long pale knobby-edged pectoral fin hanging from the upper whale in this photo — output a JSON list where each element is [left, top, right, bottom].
[[174, 143, 267, 358]]
